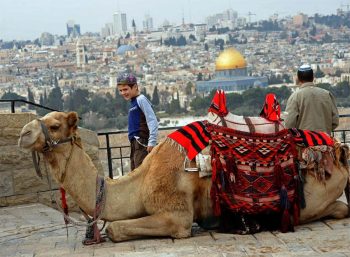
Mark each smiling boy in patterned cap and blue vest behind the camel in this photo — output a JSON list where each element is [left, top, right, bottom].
[[117, 73, 158, 170]]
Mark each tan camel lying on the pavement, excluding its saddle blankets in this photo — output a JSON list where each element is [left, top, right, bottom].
[[18, 112, 349, 242]]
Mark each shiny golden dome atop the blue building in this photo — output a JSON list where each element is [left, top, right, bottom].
[[216, 47, 247, 71]]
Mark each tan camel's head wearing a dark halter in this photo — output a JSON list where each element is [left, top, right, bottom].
[[18, 112, 79, 152]]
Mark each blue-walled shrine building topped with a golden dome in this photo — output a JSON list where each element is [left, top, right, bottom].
[[196, 48, 268, 93]]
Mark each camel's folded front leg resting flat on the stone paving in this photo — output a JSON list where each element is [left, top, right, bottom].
[[106, 212, 193, 242]]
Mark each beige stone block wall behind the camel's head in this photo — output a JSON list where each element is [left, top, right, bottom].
[[0, 113, 103, 207]]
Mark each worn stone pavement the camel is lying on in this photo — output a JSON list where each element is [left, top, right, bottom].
[[0, 204, 350, 257]]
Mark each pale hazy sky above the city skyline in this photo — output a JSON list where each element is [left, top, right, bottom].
[[0, 0, 344, 40]]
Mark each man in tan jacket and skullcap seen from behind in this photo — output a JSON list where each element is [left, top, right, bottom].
[[285, 65, 339, 134]]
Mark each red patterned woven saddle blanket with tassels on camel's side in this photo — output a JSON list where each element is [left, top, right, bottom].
[[208, 124, 299, 223]]
